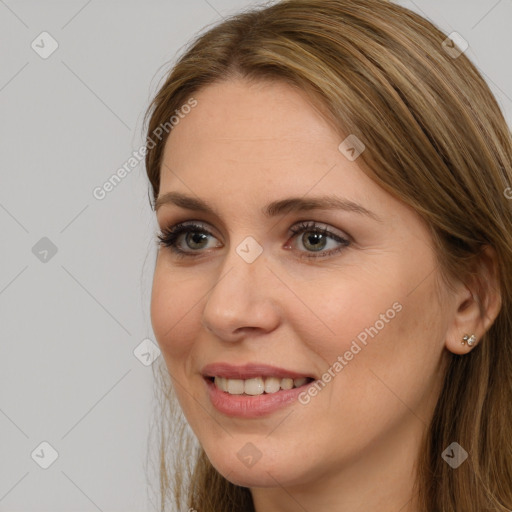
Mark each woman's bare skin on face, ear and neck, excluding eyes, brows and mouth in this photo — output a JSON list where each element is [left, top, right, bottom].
[[151, 79, 499, 512]]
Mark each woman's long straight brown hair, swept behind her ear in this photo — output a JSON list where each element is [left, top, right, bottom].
[[142, 0, 512, 512]]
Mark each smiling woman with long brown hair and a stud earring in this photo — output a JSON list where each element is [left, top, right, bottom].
[[146, 0, 512, 512]]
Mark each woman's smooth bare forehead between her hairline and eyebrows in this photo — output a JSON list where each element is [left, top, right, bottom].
[[159, 80, 408, 230]]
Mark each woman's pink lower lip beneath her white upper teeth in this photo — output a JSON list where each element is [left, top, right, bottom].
[[203, 378, 315, 418]]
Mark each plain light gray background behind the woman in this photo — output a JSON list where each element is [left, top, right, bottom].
[[0, 0, 512, 512]]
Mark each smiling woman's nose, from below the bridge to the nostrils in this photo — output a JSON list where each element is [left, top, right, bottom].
[[201, 248, 281, 341]]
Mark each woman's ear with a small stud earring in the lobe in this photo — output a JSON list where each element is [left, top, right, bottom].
[[446, 245, 502, 354]]
